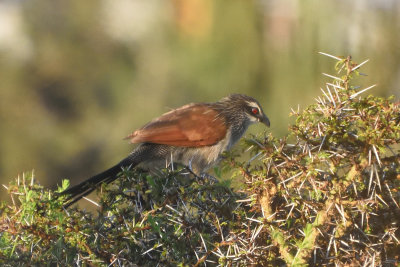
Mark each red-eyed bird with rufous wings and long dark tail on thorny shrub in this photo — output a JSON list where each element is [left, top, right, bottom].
[[61, 94, 270, 208]]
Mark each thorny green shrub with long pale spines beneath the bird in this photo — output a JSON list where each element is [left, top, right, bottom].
[[0, 55, 400, 266]]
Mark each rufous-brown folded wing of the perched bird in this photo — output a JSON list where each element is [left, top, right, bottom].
[[126, 104, 227, 147]]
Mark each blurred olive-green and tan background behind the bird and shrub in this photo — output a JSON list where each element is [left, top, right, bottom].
[[0, 0, 400, 194]]
